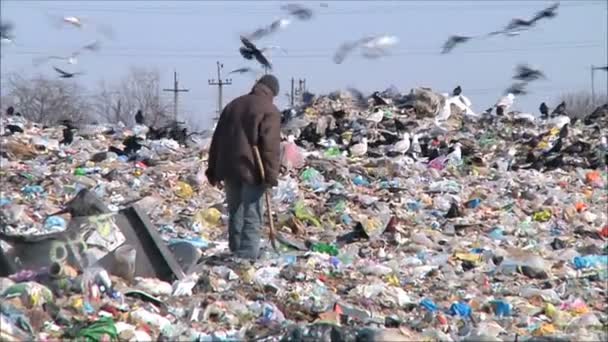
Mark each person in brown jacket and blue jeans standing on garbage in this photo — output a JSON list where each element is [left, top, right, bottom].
[[205, 75, 281, 260]]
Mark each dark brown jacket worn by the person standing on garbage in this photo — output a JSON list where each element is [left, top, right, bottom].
[[207, 83, 281, 186]]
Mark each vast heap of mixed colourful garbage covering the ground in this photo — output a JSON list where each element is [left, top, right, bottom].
[[0, 88, 608, 341]]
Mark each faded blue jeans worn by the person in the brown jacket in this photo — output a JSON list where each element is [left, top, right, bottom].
[[224, 181, 265, 259]]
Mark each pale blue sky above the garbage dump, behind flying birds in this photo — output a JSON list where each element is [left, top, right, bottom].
[[1, 0, 608, 125]]
